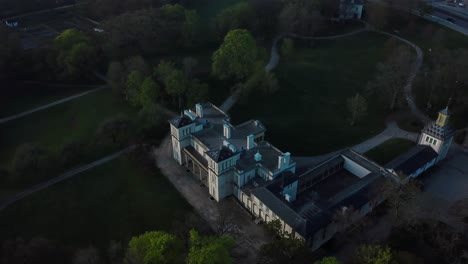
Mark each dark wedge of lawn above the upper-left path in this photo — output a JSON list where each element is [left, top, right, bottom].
[[0, 84, 97, 118]]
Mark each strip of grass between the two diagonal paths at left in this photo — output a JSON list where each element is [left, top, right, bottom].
[[0, 89, 136, 171]]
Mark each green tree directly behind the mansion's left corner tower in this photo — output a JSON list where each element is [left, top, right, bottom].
[[155, 61, 187, 108]]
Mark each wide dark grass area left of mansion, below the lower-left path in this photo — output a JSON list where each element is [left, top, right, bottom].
[[0, 157, 196, 249]]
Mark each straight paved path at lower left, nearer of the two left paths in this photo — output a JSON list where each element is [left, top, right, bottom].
[[0, 146, 135, 212]]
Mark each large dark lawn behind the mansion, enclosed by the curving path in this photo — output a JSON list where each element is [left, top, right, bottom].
[[230, 33, 388, 155]]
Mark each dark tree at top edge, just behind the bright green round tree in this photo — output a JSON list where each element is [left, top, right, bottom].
[[216, 2, 255, 39]]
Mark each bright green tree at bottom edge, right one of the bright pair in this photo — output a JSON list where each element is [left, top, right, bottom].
[[187, 230, 235, 264]]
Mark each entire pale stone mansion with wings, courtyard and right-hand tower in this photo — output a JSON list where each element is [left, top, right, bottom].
[[169, 103, 453, 250]]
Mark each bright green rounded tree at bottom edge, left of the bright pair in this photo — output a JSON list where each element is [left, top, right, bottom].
[[125, 231, 183, 264]]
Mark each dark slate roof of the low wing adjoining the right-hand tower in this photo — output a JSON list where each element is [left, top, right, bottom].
[[385, 145, 438, 176]]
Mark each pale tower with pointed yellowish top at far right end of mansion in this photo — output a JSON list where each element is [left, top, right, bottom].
[[418, 105, 455, 162]]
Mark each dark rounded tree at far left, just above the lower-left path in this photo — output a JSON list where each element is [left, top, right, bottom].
[[11, 143, 49, 182]]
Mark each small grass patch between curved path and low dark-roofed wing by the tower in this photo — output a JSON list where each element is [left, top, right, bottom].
[[364, 138, 416, 165]]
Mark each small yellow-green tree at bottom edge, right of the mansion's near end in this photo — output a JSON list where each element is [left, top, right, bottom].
[[355, 245, 393, 264]]
